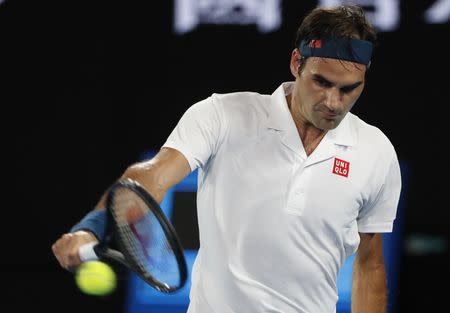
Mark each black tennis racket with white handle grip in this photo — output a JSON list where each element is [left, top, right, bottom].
[[79, 179, 187, 293]]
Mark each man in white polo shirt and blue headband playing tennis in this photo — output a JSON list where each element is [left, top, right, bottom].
[[53, 6, 401, 313]]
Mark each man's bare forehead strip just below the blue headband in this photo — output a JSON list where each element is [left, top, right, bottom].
[[304, 57, 366, 83]]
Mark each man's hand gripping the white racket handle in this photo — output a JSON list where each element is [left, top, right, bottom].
[[52, 231, 98, 272]]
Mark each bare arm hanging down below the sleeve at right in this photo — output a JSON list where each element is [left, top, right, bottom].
[[352, 233, 387, 313]]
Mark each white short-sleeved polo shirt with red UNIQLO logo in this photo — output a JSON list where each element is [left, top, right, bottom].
[[164, 83, 401, 313]]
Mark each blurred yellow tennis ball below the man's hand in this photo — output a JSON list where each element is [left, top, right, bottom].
[[75, 261, 117, 296]]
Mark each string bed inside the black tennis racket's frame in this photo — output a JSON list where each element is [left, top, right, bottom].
[[112, 189, 181, 287]]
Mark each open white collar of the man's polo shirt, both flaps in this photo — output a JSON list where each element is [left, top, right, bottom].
[[266, 82, 357, 146]]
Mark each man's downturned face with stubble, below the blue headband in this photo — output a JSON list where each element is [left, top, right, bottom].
[[290, 49, 366, 130]]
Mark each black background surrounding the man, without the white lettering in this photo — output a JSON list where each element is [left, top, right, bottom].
[[5, 0, 450, 312]]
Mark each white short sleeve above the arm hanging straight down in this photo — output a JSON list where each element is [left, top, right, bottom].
[[357, 152, 401, 233]]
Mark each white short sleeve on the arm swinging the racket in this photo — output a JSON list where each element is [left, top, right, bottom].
[[163, 96, 226, 171]]
